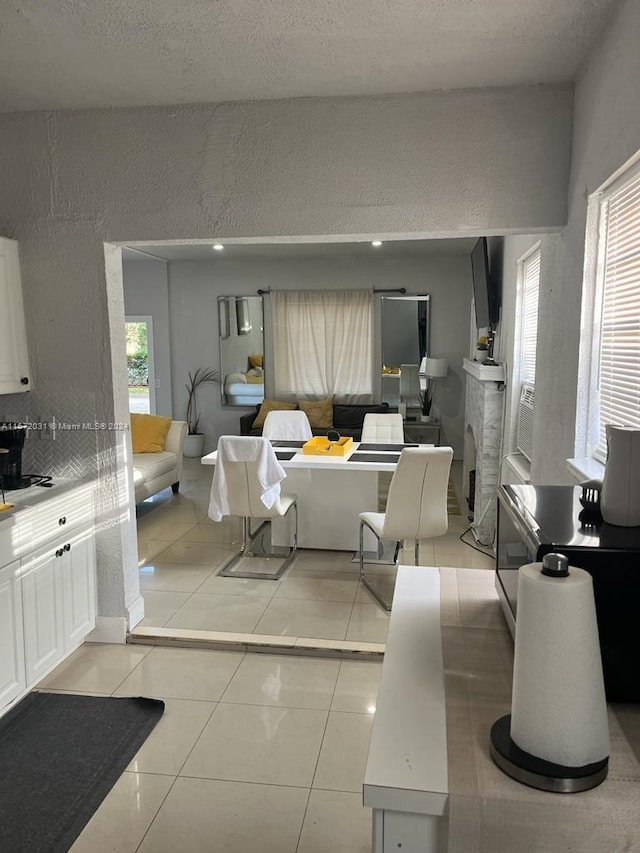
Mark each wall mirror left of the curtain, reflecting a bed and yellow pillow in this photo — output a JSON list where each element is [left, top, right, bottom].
[[218, 296, 264, 406]]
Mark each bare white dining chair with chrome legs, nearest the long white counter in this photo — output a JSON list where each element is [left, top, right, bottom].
[[360, 447, 453, 610]]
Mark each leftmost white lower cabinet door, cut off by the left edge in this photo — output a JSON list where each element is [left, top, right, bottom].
[[0, 561, 26, 708]]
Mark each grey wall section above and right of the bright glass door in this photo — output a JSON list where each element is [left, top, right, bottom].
[[122, 260, 172, 419]]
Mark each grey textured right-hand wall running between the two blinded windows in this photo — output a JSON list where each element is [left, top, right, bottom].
[[532, 0, 640, 483]]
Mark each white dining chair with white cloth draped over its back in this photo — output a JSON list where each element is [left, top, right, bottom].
[[208, 435, 298, 580]]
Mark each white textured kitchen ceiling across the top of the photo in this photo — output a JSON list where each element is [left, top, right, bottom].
[[0, 0, 617, 112]]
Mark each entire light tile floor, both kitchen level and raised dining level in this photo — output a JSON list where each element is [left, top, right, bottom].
[[32, 460, 492, 853]]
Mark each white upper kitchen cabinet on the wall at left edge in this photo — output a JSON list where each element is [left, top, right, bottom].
[[0, 237, 32, 394]]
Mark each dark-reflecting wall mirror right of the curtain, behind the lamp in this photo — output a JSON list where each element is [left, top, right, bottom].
[[381, 295, 430, 406]]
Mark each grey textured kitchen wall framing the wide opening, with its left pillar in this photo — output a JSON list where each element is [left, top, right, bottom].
[[0, 83, 572, 617]]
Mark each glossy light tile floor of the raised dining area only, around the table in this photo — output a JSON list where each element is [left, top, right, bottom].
[[137, 459, 493, 643]]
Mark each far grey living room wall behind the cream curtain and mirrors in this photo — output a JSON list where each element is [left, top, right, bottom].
[[169, 247, 471, 456]]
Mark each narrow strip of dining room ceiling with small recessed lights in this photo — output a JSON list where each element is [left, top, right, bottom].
[[122, 237, 477, 261]]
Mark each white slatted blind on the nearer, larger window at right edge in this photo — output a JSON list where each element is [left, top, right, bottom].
[[594, 172, 640, 460]]
